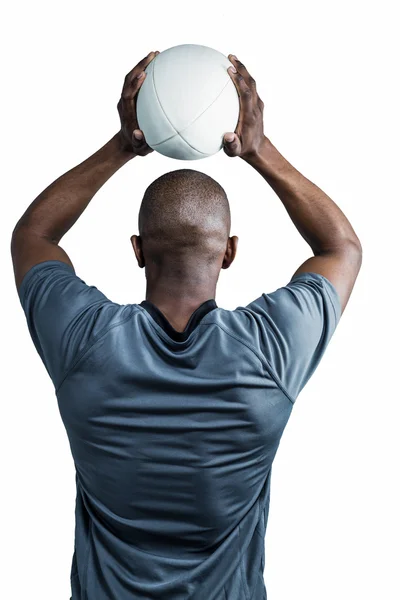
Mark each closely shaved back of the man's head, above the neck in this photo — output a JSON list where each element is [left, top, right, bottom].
[[139, 169, 231, 272]]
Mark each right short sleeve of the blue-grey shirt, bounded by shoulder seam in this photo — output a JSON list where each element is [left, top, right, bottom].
[[244, 272, 341, 402]]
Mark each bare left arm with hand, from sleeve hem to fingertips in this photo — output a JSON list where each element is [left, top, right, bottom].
[[11, 52, 157, 288]]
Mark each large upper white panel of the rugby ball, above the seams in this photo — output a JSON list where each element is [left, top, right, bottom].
[[153, 44, 233, 131]]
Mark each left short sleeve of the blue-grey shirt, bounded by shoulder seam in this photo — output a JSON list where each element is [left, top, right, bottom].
[[18, 260, 121, 388]]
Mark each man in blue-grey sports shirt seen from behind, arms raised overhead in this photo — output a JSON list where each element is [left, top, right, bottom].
[[12, 52, 362, 600]]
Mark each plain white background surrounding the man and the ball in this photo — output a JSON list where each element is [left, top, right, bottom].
[[0, 0, 400, 600]]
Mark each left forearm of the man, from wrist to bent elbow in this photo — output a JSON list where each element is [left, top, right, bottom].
[[14, 134, 135, 243]]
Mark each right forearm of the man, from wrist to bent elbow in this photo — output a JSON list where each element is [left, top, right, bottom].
[[246, 138, 360, 255]]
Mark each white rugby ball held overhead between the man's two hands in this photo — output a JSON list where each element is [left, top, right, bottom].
[[136, 44, 240, 160]]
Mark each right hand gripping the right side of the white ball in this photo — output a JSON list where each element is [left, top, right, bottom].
[[223, 54, 266, 160]]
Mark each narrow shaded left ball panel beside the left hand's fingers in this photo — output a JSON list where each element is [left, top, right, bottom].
[[136, 61, 176, 148]]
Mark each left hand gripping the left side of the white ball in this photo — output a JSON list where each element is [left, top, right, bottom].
[[117, 50, 160, 156]]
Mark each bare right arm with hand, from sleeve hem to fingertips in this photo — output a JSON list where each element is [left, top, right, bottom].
[[224, 55, 362, 312]]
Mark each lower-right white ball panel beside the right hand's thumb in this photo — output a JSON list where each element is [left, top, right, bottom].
[[180, 80, 240, 156]]
